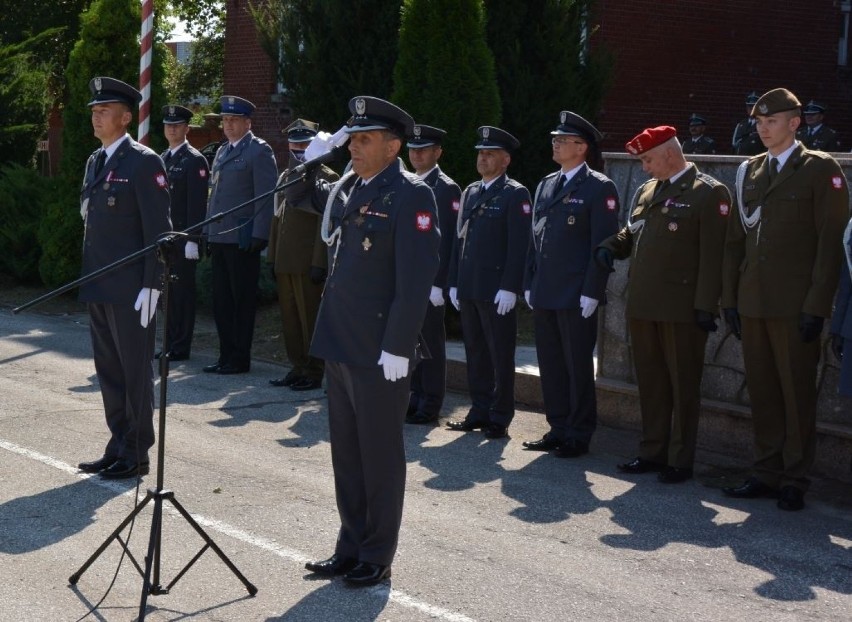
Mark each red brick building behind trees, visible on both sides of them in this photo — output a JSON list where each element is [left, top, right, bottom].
[[224, 0, 852, 154]]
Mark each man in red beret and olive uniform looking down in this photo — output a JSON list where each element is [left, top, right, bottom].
[[595, 126, 731, 484]]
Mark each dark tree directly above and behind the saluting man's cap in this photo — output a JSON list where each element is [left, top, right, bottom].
[[252, 0, 400, 132]]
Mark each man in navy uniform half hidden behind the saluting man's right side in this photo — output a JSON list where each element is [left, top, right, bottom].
[[405, 124, 461, 425]]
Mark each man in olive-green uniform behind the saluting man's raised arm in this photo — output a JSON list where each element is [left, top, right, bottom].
[[267, 119, 339, 391]]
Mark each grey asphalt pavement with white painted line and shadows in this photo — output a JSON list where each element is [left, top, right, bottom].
[[0, 310, 852, 622]]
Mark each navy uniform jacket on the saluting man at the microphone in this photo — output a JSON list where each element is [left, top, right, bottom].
[[310, 167, 440, 367]]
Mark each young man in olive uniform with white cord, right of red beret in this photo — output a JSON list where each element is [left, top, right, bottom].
[[722, 88, 849, 510]]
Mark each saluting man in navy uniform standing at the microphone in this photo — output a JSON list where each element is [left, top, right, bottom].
[[306, 96, 440, 586]]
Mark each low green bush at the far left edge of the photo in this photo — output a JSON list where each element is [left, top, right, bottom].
[[0, 164, 52, 283]]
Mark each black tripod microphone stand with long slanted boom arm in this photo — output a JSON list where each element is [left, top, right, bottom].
[[12, 163, 329, 622]]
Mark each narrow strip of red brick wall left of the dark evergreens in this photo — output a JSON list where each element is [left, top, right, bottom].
[[224, 0, 290, 164]]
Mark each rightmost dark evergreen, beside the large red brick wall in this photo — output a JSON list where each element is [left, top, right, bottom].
[[485, 0, 611, 191]]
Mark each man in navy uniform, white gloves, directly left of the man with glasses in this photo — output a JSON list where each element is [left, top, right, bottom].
[[447, 125, 532, 438]]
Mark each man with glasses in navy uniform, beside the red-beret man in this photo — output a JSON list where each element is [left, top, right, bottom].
[[524, 110, 619, 458]]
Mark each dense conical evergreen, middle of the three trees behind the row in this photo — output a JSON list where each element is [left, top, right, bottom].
[[393, 0, 500, 188]]
